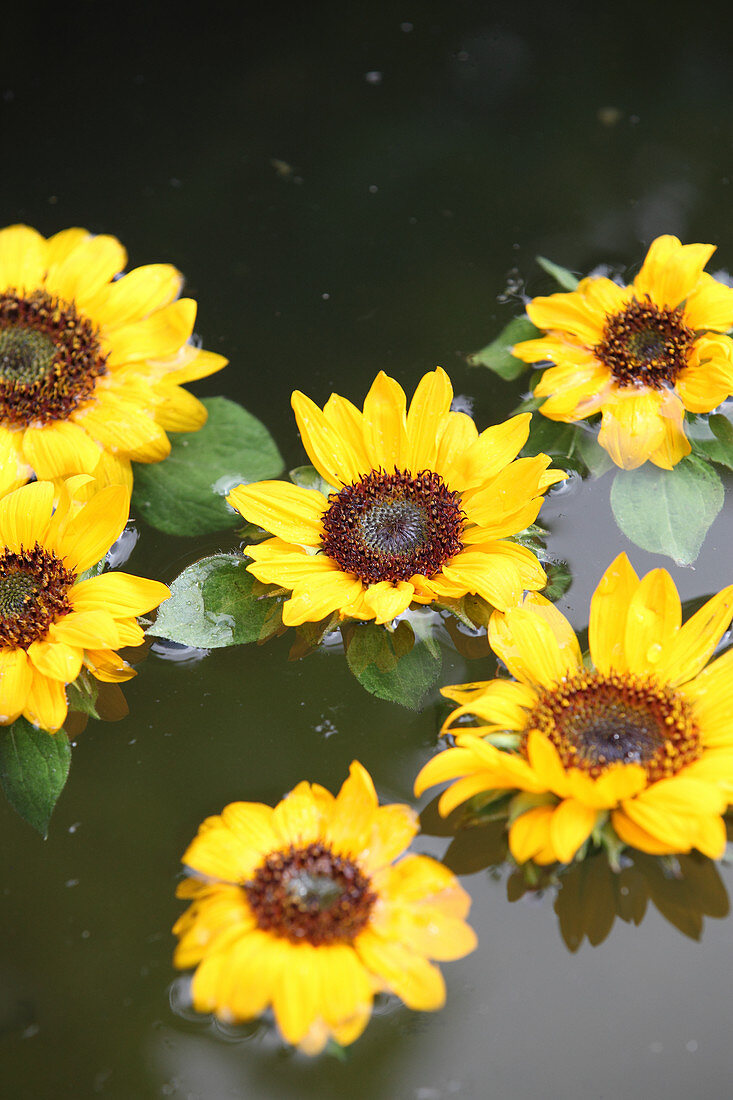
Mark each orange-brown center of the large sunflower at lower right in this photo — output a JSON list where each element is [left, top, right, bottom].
[[523, 670, 702, 782]]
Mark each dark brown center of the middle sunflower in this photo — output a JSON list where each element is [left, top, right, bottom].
[[321, 468, 464, 584]]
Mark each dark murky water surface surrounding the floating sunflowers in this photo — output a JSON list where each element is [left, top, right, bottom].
[[0, 2, 733, 1100]]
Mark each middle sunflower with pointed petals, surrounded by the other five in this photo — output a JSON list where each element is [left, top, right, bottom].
[[227, 367, 566, 626]]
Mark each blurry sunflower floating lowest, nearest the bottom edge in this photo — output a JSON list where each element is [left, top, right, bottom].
[[173, 761, 475, 1054]]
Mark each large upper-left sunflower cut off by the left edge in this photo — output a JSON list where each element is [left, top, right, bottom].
[[0, 226, 227, 493]]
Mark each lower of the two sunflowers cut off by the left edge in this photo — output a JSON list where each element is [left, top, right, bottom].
[[0, 474, 171, 733]]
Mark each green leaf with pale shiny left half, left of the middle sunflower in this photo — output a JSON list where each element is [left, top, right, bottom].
[[147, 554, 282, 649]]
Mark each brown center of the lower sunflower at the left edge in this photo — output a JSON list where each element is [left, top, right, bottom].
[[0, 542, 76, 649]]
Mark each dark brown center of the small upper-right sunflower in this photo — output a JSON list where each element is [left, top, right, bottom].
[[593, 297, 694, 389]]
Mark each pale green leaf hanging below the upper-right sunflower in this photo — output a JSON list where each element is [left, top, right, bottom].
[[611, 455, 724, 565]]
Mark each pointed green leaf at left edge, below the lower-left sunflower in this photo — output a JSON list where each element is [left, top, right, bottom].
[[0, 718, 72, 839]]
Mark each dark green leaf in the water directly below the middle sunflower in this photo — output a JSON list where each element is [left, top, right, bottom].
[[347, 620, 442, 711]]
